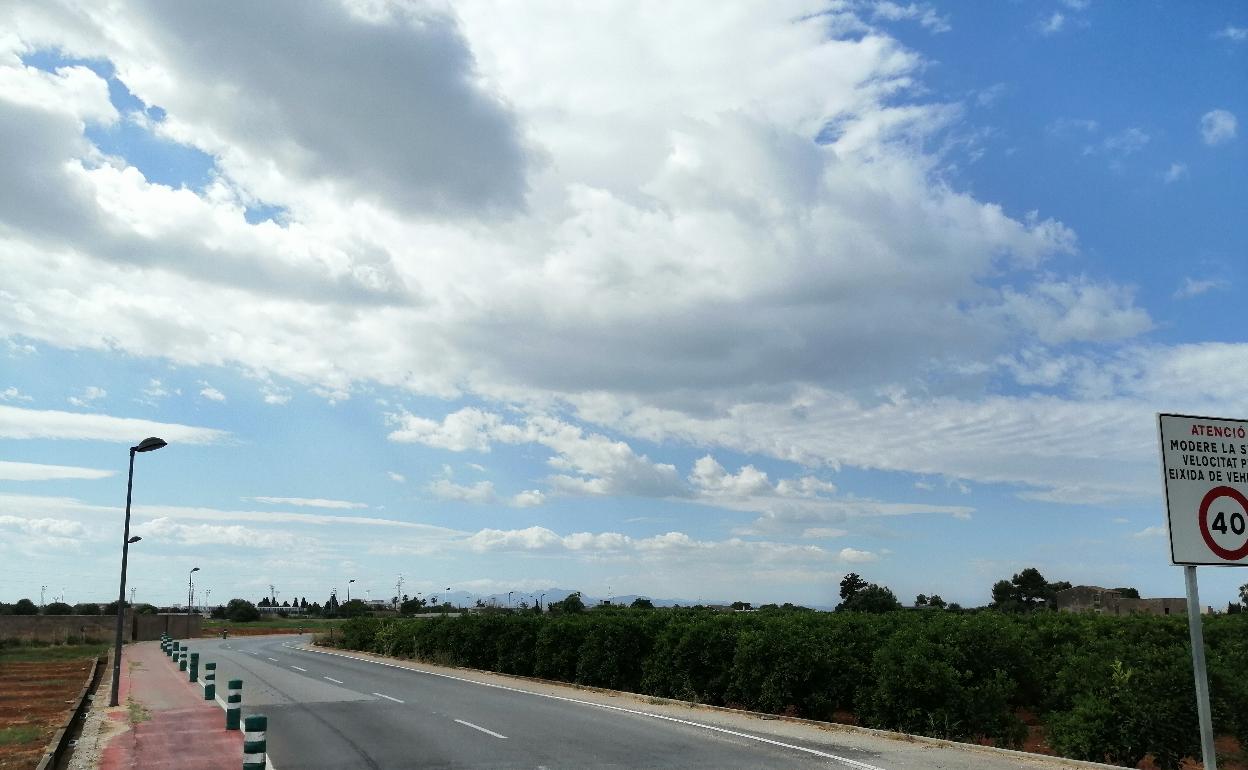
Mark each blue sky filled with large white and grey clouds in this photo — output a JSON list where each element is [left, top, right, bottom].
[[0, 0, 1248, 607]]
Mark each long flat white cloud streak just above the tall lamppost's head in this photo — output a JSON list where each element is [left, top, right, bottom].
[[0, 406, 228, 446]]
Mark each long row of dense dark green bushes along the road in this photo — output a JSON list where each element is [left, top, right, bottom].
[[338, 609, 1248, 769]]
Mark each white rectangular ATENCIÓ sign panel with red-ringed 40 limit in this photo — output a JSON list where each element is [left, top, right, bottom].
[[1157, 414, 1248, 567]]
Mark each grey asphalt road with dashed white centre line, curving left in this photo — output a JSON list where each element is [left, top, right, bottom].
[[191, 636, 1113, 770]]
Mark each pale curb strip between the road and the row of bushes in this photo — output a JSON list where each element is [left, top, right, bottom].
[[304, 644, 1124, 770]]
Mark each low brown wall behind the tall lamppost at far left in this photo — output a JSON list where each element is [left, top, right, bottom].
[[0, 610, 203, 644]]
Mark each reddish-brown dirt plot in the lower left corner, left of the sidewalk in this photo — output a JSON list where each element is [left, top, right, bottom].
[[0, 658, 92, 770]]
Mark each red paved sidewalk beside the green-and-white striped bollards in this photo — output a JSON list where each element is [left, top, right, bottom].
[[100, 641, 242, 770]]
